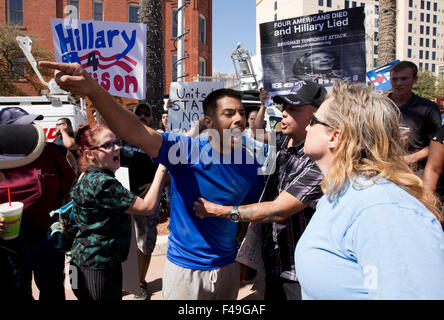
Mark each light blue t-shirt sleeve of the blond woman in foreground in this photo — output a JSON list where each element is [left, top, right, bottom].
[[345, 204, 444, 299]]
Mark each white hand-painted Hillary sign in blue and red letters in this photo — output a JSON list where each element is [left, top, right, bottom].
[[51, 19, 146, 100]]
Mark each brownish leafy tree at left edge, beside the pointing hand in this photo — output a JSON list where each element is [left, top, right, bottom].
[[0, 23, 53, 96]]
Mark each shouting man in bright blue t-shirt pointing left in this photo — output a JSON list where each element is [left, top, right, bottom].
[[40, 62, 263, 299]]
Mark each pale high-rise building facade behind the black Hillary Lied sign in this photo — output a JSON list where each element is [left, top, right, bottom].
[[256, 0, 444, 75]]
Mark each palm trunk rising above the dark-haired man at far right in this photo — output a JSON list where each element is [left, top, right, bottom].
[[378, 0, 396, 66]]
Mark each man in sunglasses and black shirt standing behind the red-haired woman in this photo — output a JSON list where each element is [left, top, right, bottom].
[[120, 103, 159, 300]]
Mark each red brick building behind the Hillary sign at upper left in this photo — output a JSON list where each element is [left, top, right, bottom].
[[0, 0, 212, 106]]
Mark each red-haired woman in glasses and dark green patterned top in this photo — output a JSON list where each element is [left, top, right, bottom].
[[71, 125, 166, 300]]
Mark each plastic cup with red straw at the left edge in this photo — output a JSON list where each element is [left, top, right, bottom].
[[0, 202, 23, 240]]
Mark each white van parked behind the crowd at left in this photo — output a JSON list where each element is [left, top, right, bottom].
[[0, 95, 87, 141]]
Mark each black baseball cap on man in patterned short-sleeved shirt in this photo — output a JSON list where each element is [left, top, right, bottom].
[[273, 81, 327, 108]]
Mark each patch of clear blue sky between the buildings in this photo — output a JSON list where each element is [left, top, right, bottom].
[[213, 0, 256, 73]]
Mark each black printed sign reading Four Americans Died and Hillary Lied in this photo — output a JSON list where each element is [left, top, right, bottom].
[[259, 7, 366, 96]]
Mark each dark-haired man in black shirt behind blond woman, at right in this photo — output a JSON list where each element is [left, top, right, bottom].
[[389, 61, 441, 175]]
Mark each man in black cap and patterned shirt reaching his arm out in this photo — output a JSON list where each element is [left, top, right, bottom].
[[195, 81, 330, 300]]
